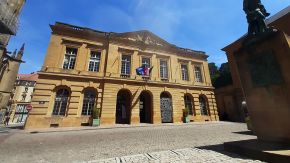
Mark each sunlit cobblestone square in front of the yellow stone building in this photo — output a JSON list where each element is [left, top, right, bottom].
[[0, 122, 256, 163]]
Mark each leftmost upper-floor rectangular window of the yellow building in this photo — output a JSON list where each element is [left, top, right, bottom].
[[63, 48, 78, 69]]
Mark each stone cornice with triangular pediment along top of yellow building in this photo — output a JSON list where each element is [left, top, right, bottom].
[[50, 22, 208, 60]]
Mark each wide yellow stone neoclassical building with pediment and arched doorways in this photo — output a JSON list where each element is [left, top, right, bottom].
[[26, 22, 218, 128]]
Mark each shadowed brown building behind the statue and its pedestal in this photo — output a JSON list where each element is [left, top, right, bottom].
[[215, 6, 290, 121]]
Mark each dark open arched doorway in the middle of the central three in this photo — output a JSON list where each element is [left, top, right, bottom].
[[139, 91, 153, 123]]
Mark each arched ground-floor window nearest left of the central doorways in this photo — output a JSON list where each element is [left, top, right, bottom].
[[82, 90, 96, 115]]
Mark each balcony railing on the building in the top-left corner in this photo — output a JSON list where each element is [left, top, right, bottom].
[[0, 3, 18, 35]]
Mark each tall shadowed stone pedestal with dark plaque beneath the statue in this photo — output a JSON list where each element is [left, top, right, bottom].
[[234, 32, 290, 143]]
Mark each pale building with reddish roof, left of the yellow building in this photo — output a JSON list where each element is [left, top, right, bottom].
[[9, 73, 38, 124]]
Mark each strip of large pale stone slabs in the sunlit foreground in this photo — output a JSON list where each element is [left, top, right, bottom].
[[84, 148, 261, 163]]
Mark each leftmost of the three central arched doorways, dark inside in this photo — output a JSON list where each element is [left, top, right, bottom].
[[116, 89, 131, 124]]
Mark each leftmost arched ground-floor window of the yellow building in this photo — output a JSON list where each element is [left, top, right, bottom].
[[52, 89, 69, 116]]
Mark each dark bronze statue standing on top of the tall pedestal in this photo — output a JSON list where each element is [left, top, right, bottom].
[[243, 0, 270, 36]]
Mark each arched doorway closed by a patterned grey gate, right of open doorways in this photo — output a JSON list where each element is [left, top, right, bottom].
[[160, 92, 173, 123]]
